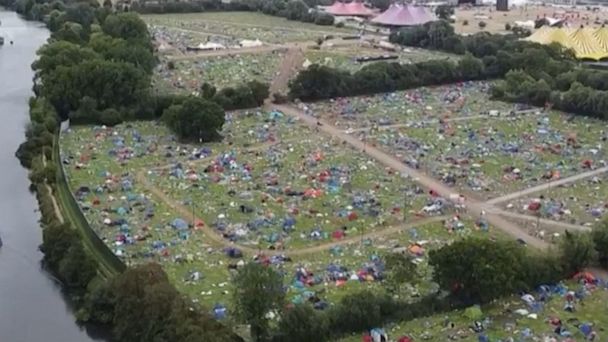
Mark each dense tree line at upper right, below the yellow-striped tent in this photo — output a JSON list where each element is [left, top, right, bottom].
[[390, 21, 608, 120]]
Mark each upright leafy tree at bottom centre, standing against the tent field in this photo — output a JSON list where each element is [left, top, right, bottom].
[[232, 262, 285, 342]]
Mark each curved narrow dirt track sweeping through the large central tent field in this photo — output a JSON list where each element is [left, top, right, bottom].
[[135, 170, 447, 256]]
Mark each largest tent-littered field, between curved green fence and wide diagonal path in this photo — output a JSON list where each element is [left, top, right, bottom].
[[61, 111, 486, 305]]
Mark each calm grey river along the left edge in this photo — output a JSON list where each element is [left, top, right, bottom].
[[0, 8, 103, 342]]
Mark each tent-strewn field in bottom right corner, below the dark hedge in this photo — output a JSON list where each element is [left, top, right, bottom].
[[340, 281, 608, 342]]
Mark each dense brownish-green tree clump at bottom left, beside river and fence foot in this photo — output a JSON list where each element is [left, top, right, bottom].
[[80, 264, 241, 342]]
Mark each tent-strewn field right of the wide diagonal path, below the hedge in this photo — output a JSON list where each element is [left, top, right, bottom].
[[307, 83, 606, 199]]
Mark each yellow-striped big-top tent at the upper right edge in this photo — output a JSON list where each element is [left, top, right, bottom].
[[526, 26, 608, 60]]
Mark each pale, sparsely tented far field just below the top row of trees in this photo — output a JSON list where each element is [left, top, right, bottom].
[[142, 12, 355, 44]]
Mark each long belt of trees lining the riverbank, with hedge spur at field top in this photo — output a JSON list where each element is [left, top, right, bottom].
[[3, 0, 249, 342]]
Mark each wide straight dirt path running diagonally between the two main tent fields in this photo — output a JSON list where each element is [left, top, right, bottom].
[[266, 105, 549, 249]]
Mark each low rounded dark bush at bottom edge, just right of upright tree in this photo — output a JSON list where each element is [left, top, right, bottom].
[[273, 304, 329, 342]]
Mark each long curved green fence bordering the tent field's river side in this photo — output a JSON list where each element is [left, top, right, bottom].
[[53, 132, 127, 276]]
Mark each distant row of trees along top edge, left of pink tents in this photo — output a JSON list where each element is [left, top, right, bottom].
[[131, 0, 334, 25]]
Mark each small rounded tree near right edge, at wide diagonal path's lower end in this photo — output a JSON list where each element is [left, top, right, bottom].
[[559, 231, 597, 274]]
